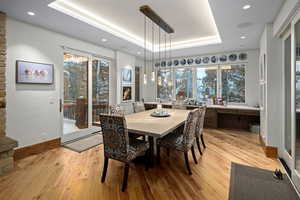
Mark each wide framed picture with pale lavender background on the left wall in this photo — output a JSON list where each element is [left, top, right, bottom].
[[16, 60, 54, 84]]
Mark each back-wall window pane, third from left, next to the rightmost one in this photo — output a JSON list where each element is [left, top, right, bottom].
[[196, 67, 218, 101]]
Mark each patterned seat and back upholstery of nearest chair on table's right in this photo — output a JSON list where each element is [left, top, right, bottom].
[[157, 109, 199, 152]]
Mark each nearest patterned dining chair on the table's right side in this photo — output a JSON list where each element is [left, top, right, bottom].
[[157, 109, 199, 175]]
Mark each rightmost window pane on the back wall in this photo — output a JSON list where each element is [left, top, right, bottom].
[[221, 65, 245, 103]]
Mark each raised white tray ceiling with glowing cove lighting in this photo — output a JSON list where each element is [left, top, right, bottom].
[[49, 0, 221, 50]]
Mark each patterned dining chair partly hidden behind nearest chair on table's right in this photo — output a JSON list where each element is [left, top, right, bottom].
[[195, 106, 206, 155]]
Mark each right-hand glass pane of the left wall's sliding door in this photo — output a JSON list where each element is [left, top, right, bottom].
[[92, 59, 109, 123]]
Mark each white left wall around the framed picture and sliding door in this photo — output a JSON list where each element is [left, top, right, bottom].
[[7, 18, 116, 147]]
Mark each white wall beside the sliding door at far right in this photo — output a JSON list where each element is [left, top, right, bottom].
[[260, 24, 283, 149]]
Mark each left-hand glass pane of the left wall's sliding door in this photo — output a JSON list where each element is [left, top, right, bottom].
[[63, 53, 88, 133]]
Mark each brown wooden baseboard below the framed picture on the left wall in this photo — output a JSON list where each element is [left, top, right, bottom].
[[14, 138, 61, 160]]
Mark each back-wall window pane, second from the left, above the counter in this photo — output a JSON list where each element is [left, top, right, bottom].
[[175, 69, 193, 100]]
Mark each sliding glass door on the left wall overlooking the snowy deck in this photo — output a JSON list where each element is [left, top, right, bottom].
[[61, 51, 110, 142]]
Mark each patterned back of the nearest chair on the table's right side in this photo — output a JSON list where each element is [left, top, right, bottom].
[[183, 109, 199, 148]]
